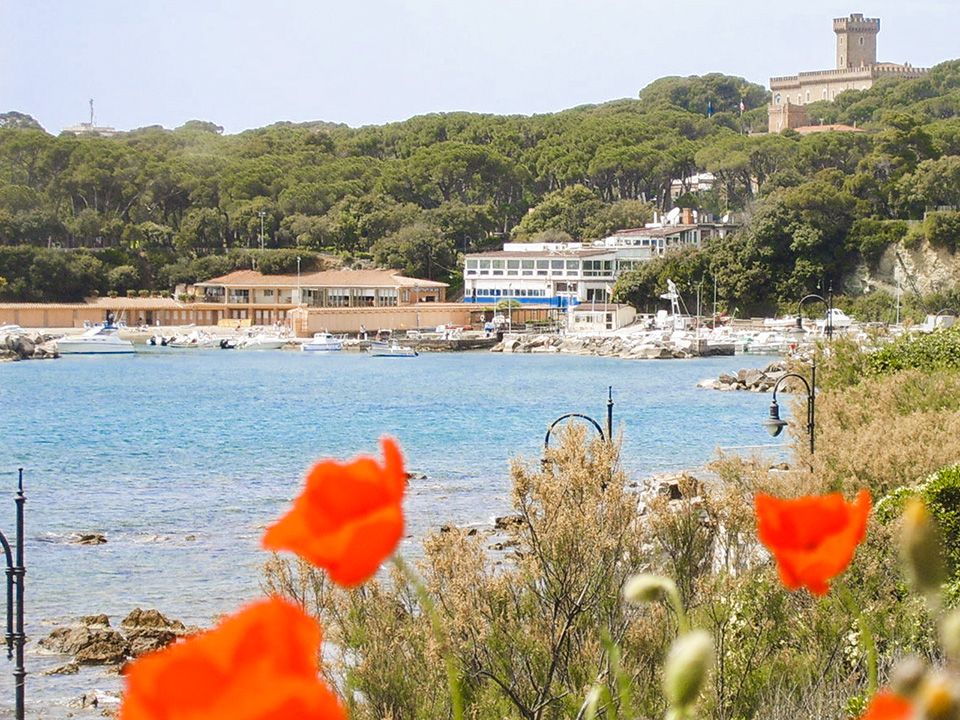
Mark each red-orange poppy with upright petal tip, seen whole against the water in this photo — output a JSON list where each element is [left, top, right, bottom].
[[263, 438, 407, 587]]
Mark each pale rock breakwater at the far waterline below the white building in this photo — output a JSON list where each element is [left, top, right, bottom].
[[490, 334, 695, 360]]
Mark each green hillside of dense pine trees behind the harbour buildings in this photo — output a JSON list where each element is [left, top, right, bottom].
[[0, 61, 960, 304]]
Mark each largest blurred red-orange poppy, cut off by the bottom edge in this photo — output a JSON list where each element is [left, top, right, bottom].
[[120, 598, 346, 720]]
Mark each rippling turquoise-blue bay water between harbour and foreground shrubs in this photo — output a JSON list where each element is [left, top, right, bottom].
[[0, 351, 769, 717]]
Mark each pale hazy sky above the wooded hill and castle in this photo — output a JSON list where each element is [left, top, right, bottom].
[[0, 0, 960, 133]]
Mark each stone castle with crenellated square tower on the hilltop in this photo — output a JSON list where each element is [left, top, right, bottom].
[[769, 13, 928, 133]]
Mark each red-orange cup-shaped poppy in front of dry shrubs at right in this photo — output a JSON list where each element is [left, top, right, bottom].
[[755, 490, 870, 595]]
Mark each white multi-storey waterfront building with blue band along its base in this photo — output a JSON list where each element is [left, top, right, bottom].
[[463, 208, 737, 307]]
